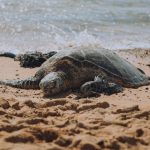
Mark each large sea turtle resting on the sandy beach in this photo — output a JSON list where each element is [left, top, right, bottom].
[[0, 47, 150, 96]]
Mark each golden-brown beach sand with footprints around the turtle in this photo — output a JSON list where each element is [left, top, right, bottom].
[[0, 49, 150, 150]]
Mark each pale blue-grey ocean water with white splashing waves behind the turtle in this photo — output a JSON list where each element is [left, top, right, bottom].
[[0, 0, 150, 53]]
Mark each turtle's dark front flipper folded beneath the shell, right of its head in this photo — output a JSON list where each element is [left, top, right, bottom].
[[80, 77, 123, 97]]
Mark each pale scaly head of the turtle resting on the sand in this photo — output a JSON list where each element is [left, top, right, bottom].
[[39, 72, 67, 96]]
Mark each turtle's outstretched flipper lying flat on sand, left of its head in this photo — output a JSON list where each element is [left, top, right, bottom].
[[0, 77, 40, 89]]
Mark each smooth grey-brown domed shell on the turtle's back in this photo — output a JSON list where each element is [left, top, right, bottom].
[[41, 47, 149, 87]]
